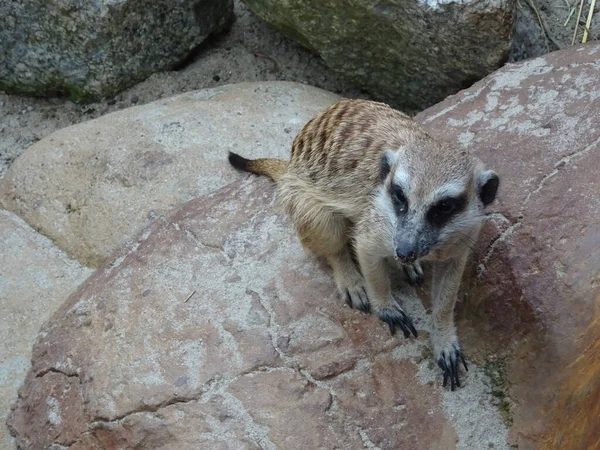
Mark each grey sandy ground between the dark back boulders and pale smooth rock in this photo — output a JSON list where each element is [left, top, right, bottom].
[[0, 0, 364, 178]]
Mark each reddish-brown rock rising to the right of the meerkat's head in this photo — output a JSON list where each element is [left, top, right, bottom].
[[417, 42, 600, 448]]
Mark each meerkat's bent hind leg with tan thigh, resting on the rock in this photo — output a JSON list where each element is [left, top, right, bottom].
[[298, 214, 371, 313]]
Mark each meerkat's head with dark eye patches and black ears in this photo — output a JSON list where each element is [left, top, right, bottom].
[[376, 139, 499, 263]]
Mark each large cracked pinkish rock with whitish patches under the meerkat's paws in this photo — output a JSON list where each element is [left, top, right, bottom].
[[9, 178, 506, 450]]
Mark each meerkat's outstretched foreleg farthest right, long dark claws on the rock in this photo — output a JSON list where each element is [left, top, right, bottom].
[[431, 254, 469, 390]]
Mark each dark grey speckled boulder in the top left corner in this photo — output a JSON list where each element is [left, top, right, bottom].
[[0, 0, 233, 100]]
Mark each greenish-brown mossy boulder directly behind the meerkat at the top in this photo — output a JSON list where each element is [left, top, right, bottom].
[[239, 0, 515, 111]]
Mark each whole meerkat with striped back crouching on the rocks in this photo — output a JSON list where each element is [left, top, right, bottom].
[[229, 99, 499, 390]]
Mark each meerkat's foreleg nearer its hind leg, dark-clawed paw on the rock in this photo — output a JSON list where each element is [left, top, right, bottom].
[[356, 237, 417, 337]]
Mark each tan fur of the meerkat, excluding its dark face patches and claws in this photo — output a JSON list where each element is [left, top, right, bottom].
[[227, 100, 500, 386]]
